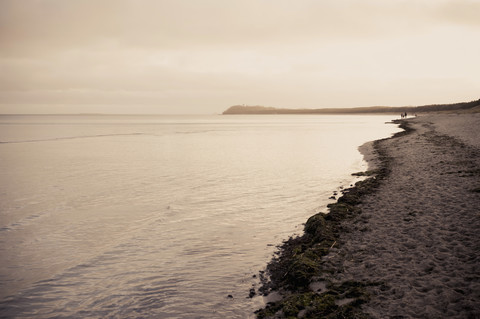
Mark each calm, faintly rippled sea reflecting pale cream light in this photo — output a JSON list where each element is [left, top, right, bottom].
[[0, 115, 397, 318]]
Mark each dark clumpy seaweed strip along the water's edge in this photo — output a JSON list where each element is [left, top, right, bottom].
[[255, 120, 414, 318]]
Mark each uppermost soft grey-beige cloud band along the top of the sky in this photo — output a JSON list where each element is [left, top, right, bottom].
[[0, 0, 466, 56]]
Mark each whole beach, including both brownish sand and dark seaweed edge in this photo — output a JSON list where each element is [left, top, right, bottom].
[[256, 114, 480, 318]]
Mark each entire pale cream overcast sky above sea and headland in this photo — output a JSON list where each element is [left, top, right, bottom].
[[0, 0, 480, 114]]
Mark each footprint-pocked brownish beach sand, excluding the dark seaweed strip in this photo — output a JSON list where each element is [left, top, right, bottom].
[[323, 113, 480, 318]]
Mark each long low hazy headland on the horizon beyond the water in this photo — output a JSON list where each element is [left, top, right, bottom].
[[222, 99, 480, 115]]
